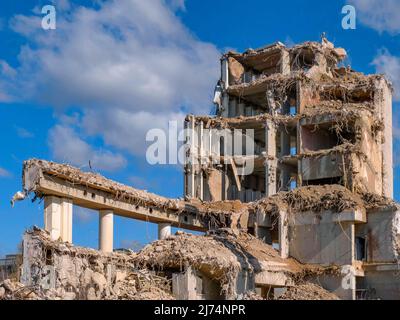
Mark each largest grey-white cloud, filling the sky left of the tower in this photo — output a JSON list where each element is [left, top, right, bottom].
[[0, 0, 219, 156]]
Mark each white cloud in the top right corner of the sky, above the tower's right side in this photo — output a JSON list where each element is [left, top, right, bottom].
[[348, 0, 400, 34]]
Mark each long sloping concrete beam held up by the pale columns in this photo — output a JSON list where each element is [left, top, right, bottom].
[[35, 174, 206, 230]]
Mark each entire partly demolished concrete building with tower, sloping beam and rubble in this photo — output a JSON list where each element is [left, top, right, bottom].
[[0, 39, 400, 299]]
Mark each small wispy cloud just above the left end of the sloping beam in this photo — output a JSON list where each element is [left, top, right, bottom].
[[49, 124, 126, 171]]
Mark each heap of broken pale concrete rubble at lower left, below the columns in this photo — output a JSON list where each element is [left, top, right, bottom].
[[10, 228, 173, 300]]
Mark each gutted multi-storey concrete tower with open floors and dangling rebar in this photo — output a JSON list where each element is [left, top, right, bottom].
[[185, 39, 393, 202]]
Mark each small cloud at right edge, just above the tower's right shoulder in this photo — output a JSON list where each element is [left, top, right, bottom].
[[372, 49, 400, 101]]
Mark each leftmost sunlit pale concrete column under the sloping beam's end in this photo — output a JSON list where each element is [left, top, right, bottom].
[[44, 196, 62, 240]]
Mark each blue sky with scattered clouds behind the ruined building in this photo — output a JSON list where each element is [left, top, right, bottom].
[[0, 0, 400, 256]]
